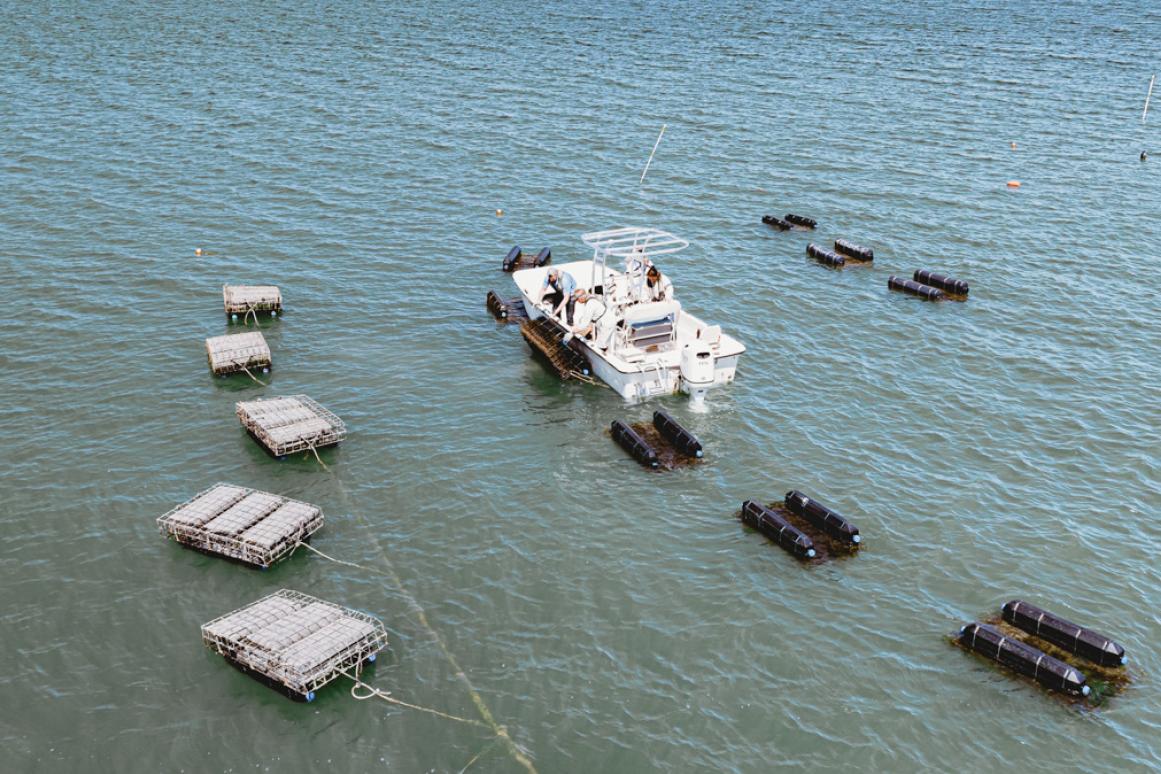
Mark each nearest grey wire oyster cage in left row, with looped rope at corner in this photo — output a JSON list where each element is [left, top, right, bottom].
[[202, 588, 387, 701]]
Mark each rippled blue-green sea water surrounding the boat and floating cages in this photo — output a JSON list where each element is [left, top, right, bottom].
[[0, 0, 1161, 772]]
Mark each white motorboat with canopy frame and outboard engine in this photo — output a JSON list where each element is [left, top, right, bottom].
[[512, 227, 745, 403]]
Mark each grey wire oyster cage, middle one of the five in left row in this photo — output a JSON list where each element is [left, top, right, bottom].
[[235, 395, 347, 457]]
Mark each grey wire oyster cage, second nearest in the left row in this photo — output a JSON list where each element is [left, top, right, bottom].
[[157, 484, 323, 569]]
